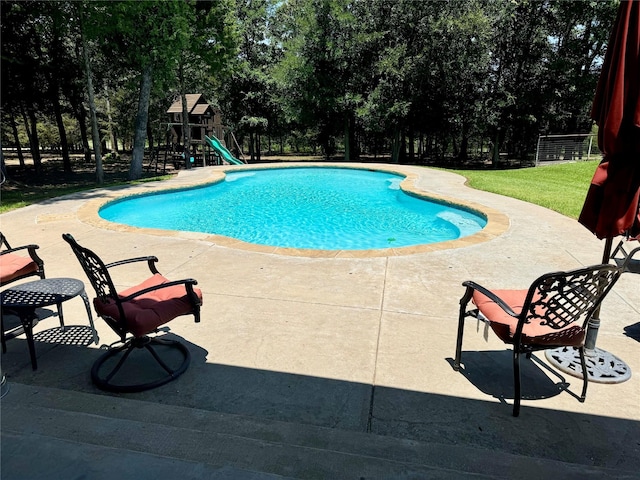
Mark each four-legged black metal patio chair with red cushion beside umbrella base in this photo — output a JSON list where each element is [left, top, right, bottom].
[[453, 264, 622, 417]]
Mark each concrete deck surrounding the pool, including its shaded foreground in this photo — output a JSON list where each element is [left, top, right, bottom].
[[0, 164, 640, 479]]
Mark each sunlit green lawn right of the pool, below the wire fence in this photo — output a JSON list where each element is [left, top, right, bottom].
[[450, 161, 599, 219]]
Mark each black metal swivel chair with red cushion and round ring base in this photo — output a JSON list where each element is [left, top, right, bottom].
[[62, 234, 202, 392]]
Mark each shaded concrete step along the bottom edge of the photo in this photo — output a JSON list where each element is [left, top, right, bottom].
[[2, 383, 637, 480]]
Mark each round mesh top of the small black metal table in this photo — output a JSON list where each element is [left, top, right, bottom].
[[0, 278, 84, 308]]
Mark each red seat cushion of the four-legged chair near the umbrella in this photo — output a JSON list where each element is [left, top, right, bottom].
[[473, 290, 586, 347]]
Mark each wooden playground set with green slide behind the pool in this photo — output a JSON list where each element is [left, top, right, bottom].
[[147, 93, 246, 173]]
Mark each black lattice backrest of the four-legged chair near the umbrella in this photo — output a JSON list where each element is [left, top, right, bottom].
[[516, 264, 622, 336]]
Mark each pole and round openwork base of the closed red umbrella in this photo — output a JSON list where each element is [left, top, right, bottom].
[[545, 238, 631, 383]]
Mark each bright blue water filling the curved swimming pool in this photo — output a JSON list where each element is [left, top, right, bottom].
[[100, 167, 486, 250]]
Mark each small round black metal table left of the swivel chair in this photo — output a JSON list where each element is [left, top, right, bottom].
[[0, 278, 98, 370]]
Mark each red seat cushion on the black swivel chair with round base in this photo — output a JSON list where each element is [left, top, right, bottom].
[[93, 273, 202, 337]]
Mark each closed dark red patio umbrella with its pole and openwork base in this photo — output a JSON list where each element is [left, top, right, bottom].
[[547, 0, 640, 383]]
